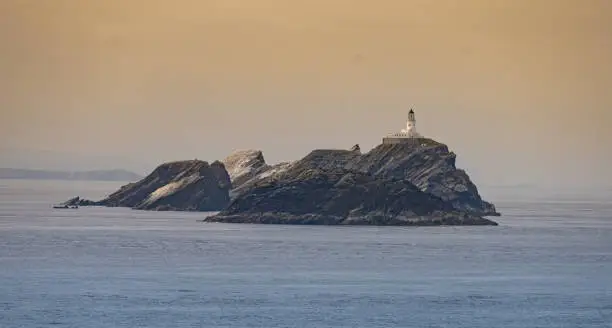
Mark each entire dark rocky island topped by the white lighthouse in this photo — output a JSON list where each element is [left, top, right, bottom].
[[65, 111, 499, 226]]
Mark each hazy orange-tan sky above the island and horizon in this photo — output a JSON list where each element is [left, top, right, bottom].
[[0, 0, 612, 185]]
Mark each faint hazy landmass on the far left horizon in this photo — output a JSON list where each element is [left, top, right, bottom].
[[0, 168, 142, 181]]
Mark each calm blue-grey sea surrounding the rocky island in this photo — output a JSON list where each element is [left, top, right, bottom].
[[0, 180, 612, 328]]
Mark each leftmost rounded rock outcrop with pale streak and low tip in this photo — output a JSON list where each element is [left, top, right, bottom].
[[65, 160, 231, 211]]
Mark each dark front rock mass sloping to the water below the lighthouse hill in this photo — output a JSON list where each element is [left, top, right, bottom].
[[204, 144, 496, 225]]
